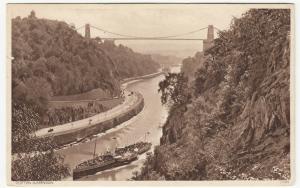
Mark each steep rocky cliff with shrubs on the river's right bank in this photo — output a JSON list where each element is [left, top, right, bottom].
[[137, 9, 290, 180]]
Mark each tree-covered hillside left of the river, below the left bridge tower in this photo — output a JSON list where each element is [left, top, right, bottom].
[[12, 12, 158, 114]]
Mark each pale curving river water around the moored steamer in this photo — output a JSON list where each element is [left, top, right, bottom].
[[58, 67, 179, 181]]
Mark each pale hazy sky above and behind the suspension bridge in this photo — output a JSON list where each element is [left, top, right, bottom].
[[8, 4, 253, 57]]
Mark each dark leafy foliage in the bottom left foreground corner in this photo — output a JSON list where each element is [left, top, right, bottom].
[[11, 103, 69, 181]]
